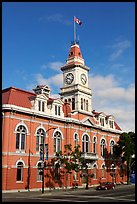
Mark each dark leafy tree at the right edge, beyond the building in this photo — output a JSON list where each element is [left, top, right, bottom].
[[114, 132, 135, 184]]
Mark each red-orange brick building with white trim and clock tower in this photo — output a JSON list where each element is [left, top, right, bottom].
[[2, 43, 125, 192]]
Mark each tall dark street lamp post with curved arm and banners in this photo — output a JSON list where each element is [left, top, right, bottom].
[[42, 128, 56, 193]]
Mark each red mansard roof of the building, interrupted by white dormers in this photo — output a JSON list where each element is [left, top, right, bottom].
[[2, 87, 122, 131]]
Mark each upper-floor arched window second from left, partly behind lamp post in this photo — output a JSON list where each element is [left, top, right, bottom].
[[36, 128, 46, 151]]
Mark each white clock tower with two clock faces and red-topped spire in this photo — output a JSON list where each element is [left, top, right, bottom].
[[60, 42, 92, 114]]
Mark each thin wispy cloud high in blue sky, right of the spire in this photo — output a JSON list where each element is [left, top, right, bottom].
[[109, 40, 131, 61]]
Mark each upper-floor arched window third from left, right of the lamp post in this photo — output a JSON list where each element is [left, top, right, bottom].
[[54, 131, 62, 152]]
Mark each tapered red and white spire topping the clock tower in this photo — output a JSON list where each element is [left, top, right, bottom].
[[67, 42, 84, 65]]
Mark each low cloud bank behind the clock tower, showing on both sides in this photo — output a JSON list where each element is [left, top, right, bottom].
[[26, 73, 135, 132]]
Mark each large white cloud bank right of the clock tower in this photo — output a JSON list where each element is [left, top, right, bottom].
[[89, 75, 135, 132]]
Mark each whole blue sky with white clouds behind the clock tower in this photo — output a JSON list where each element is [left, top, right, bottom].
[[2, 2, 135, 132]]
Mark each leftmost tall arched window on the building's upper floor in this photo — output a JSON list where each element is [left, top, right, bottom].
[[16, 125, 27, 150]]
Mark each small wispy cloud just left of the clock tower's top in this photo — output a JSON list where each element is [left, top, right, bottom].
[[41, 61, 64, 71]]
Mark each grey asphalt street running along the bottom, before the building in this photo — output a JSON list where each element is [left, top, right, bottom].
[[2, 185, 135, 203]]
